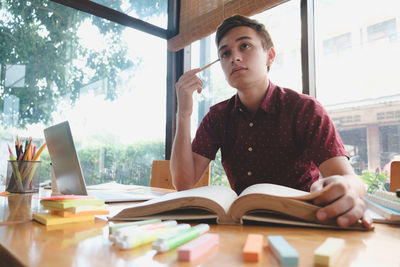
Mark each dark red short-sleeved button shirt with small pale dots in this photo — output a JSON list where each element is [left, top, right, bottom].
[[192, 82, 348, 194]]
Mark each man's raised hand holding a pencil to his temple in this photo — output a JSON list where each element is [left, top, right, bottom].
[[175, 68, 203, 117]]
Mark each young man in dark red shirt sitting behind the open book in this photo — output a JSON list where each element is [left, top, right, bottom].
[[171, 15, 371, 227]]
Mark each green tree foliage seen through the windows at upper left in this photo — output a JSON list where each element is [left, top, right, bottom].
[[0, 0, 167, 128]]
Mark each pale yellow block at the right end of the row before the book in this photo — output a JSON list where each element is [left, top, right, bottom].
[[314, 237, 345, 266]]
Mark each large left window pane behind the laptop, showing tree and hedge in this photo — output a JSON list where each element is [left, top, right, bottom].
[[0, 1, 167, 185]]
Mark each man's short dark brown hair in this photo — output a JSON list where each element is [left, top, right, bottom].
[[215, 15, 274, 50]]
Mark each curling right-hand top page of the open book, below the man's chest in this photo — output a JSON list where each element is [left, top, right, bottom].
[[239, 183, 324, 200]]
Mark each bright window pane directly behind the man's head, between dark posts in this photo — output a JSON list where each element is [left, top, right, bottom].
[[191, 0, 302, 185]]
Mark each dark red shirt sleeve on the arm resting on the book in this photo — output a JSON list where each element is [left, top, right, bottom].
[[295, 99, 349, 166]]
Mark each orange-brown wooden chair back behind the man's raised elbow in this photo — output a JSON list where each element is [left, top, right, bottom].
[[150, 160, 211, 189]]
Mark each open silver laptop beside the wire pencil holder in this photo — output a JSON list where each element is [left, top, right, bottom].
[[44, 121, 164, 203]]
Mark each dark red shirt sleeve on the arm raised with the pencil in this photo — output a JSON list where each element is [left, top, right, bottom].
[[192, 111, 221, 160]]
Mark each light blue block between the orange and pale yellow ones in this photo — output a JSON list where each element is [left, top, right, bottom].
[[267, 235, 299, 266]]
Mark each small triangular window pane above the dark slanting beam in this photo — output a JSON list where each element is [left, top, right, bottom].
[[91, 0, 168, 29]]
